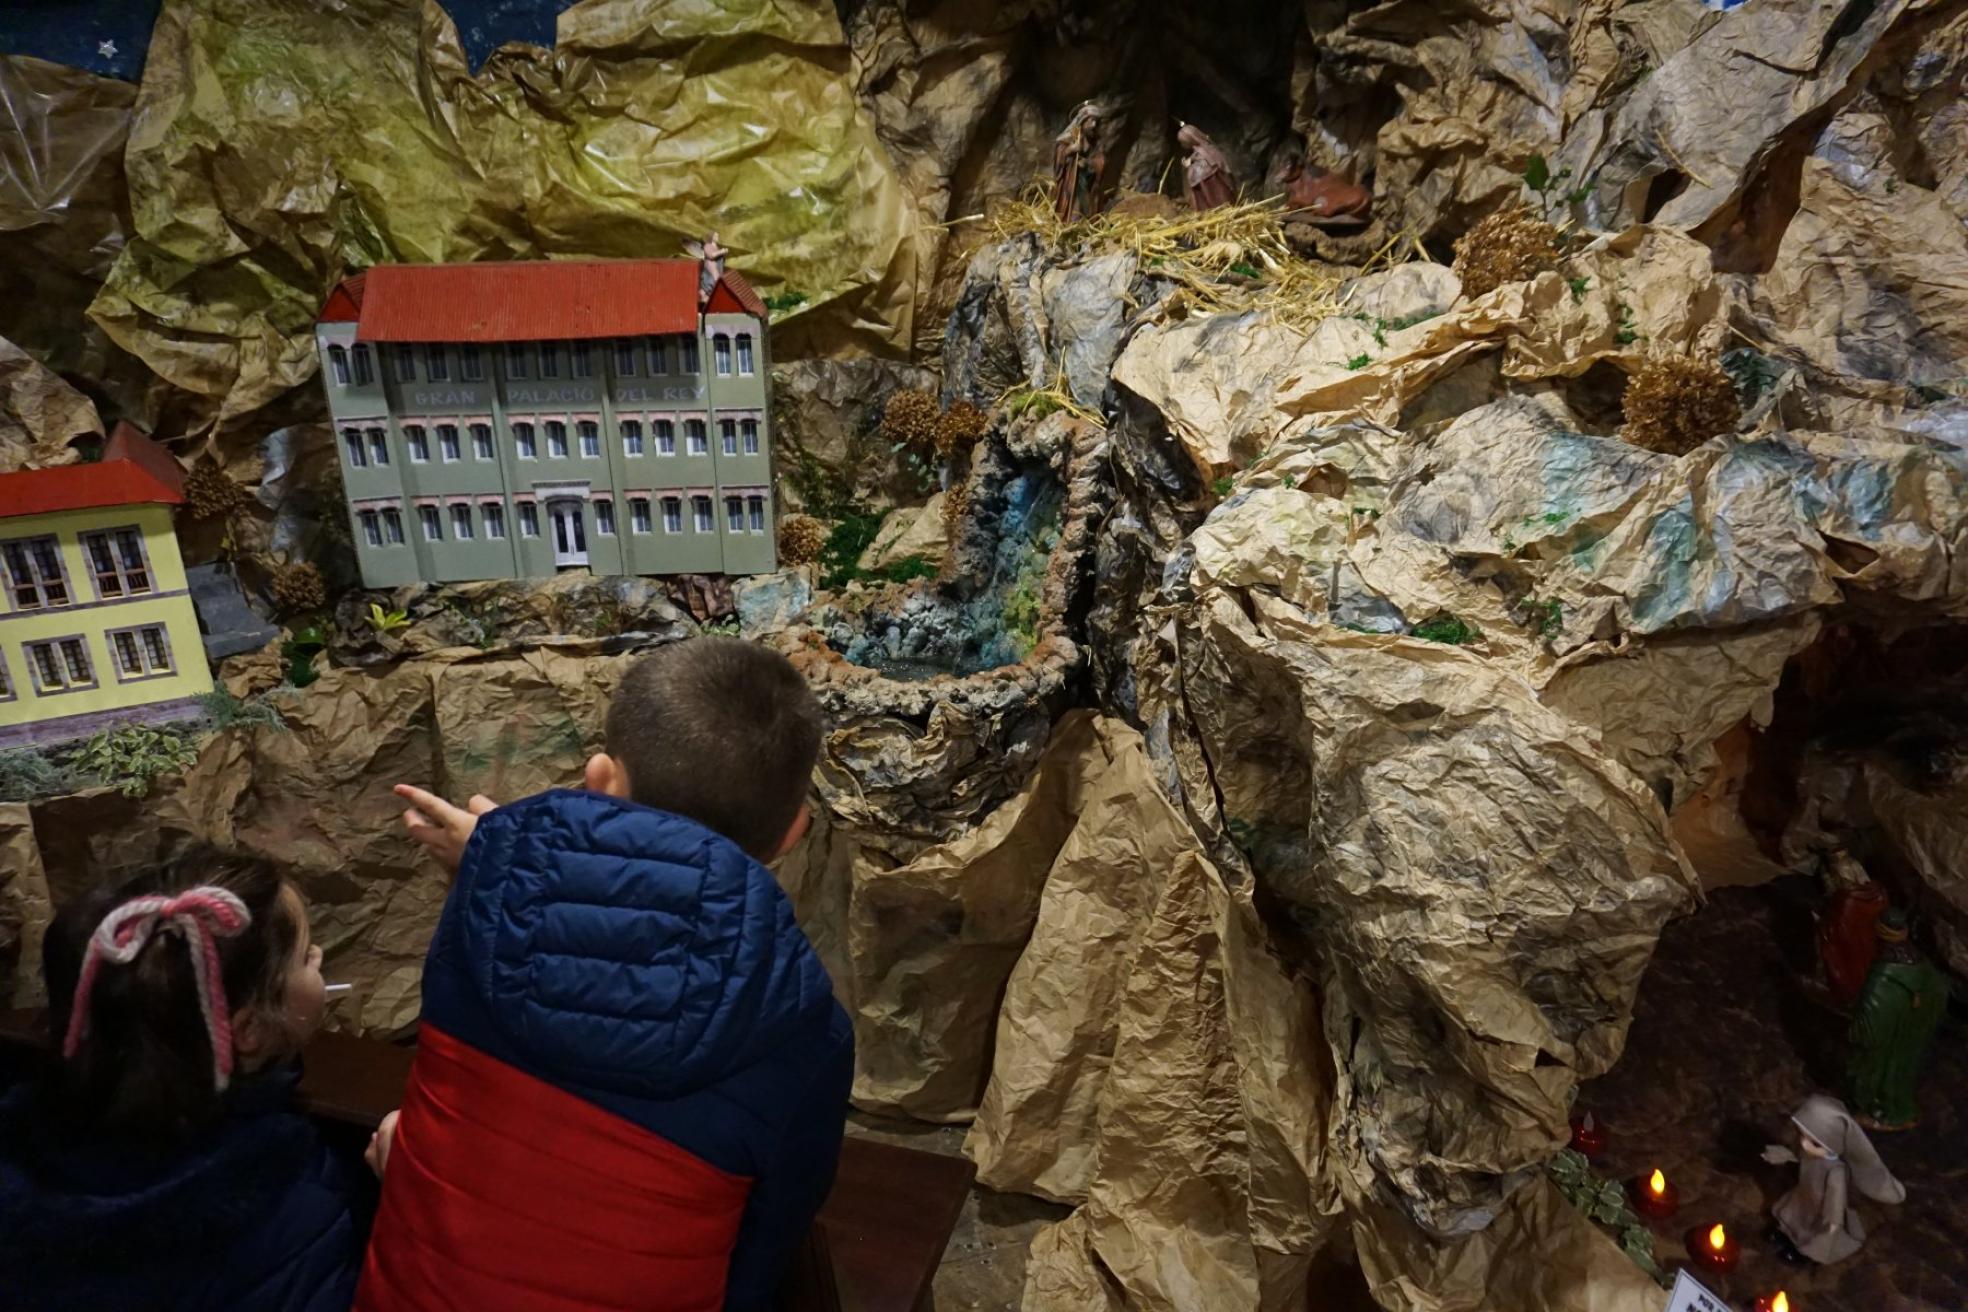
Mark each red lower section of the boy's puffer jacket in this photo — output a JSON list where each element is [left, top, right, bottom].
[[356, 1025, 752, 1312]]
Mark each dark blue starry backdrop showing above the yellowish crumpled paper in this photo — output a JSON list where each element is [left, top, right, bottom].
[[0, 0, 575, 83]]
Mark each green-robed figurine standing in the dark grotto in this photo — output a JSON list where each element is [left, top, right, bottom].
[[1846, 907, 1948, 1129]]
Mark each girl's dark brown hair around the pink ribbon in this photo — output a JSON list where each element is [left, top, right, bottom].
[[41, 848, 301, 1139]]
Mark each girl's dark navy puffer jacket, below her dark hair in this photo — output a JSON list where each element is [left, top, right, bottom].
[[0, 1068, 372, 1312]]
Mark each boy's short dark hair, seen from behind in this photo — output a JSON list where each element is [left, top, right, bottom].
[[606, 637, 821, 862]]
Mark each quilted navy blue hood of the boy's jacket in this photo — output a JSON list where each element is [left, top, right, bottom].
[[446, 791, 832, 1098]]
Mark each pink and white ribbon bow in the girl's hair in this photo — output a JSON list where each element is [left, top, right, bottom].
[[61, 883, 252, 1090]]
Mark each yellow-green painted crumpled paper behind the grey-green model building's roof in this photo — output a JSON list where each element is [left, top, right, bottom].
[[92, 0, 915, 446]]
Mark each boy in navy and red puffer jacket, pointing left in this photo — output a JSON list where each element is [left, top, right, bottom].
[[356, 637, 854, 1312]]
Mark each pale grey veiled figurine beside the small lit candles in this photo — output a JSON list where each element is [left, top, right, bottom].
[[1763, 1094, 1907, 1265]]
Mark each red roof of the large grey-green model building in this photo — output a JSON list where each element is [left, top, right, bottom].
[[331, 260, 739, 342]]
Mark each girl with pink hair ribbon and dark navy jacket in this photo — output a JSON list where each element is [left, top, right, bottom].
[[0, 850, 366, 1312]]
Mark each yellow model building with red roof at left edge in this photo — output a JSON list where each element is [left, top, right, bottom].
[[0, 425, 213, 747]]
